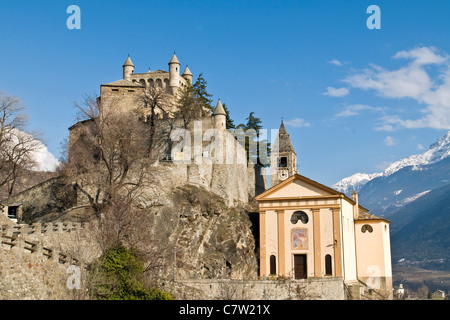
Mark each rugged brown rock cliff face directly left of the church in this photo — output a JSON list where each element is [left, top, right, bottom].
[[152, 185, 258, 279]]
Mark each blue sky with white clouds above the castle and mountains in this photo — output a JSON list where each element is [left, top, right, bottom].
[[0, 0, 450, 185]]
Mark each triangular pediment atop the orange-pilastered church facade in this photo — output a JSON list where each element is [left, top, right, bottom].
[[256, 174, 344, 201]]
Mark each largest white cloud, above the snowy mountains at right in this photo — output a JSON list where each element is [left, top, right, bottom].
[[343, 47, 450, 131]]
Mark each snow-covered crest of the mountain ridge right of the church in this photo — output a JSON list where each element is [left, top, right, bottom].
[[333, 131, 450, 195]]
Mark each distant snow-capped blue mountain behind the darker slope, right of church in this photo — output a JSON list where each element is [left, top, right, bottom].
[[333, 131, 450, 217]]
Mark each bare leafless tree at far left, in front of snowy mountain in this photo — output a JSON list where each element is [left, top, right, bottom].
[[0, 92, 40, 196]]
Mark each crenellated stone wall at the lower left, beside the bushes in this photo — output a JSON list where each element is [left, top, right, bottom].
[[0, 219, 100, 300]]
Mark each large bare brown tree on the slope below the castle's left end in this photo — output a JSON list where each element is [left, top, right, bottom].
[[66, 96, 155, 217]]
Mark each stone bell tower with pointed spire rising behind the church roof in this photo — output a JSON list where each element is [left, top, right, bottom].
[[270, 121, 298, 187]]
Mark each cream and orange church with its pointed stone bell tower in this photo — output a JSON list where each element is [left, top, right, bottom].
[[256, 123, 392, 299]]
